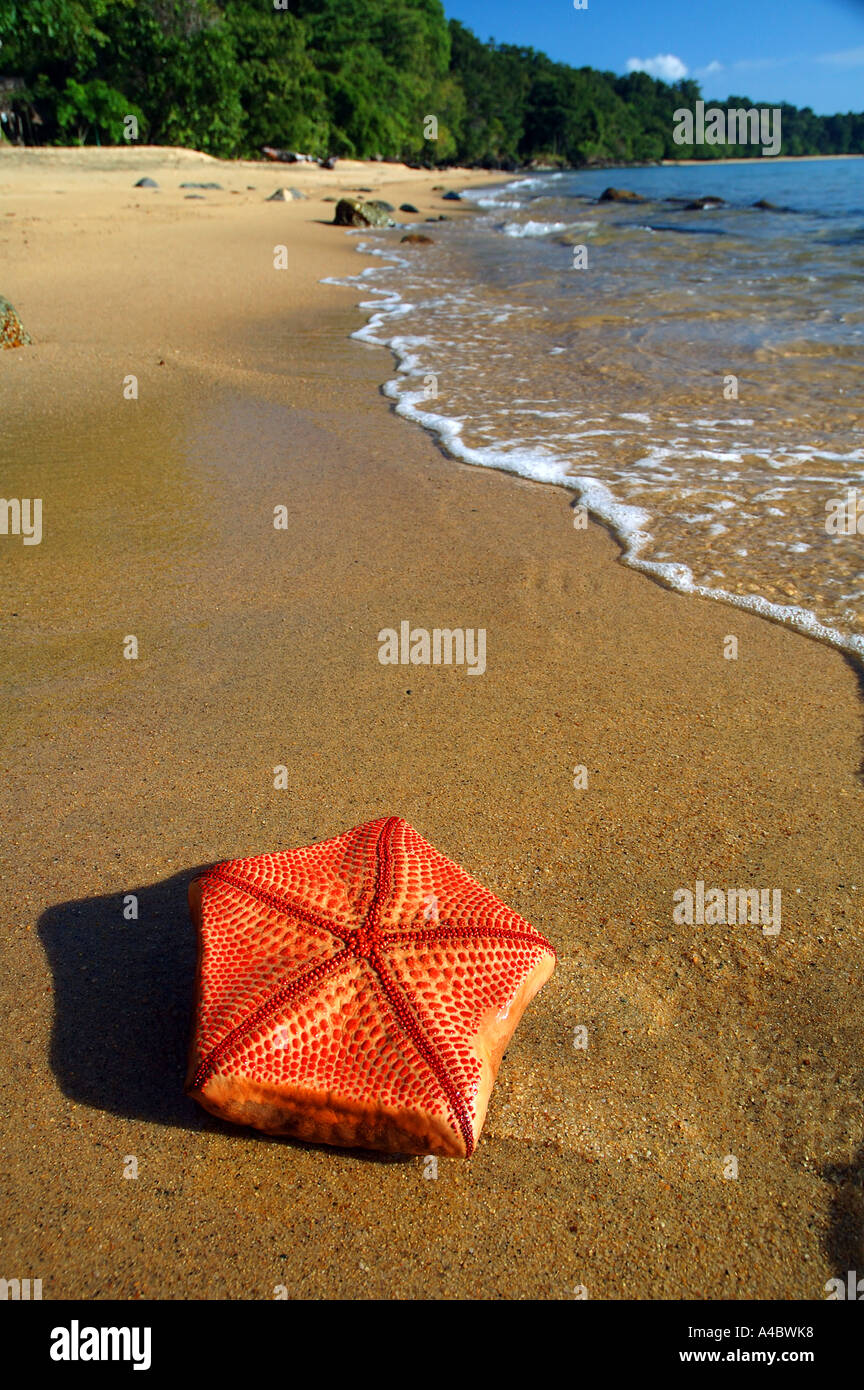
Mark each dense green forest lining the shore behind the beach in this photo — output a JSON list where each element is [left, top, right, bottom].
[[0, 0, 864, 170]]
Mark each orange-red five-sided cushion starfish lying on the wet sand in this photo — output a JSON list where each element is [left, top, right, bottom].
[[186, 816, 556, 1156]]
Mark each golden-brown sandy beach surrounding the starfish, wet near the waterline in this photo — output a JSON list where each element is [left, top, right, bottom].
[[0, 149, 864, 1300]]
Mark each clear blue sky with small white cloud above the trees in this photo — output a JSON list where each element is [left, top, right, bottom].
[[443, 0, 864, 115]]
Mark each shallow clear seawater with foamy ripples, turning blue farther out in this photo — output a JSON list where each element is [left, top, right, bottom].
[[327, 158, 864, 659]]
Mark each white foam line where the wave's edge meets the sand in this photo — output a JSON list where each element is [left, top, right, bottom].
[[324, 233, 864, 667]]
